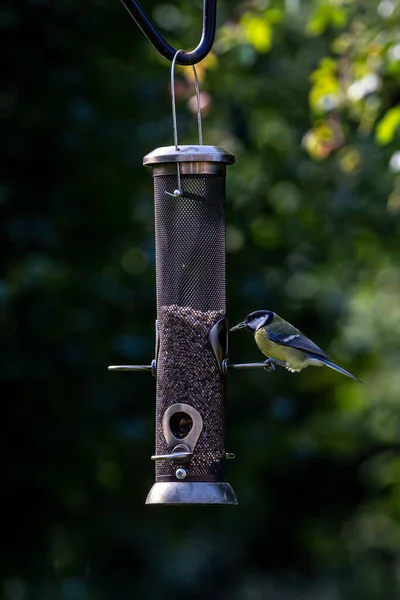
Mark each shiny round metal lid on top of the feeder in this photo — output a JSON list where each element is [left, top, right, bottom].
[[143, 145, 236, 165]]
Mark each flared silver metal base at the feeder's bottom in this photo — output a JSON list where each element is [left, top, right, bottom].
[[146, 481, 238, 505]]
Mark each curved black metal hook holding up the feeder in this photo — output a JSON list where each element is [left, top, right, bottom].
[[121, 0, 217, 65]]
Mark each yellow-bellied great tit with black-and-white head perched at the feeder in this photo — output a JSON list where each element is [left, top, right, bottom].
[[230, 310, 361, 383]]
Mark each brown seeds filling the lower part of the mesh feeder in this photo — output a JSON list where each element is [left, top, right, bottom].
[[156, 304, 225, 478]]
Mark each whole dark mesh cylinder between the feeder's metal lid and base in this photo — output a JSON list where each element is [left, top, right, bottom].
[[154, 175, 226, 481]]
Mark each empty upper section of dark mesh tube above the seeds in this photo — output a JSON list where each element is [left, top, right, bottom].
[[154, 175, 225, 311]]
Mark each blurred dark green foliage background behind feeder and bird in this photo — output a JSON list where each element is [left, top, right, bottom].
[[0, 0, 400, 600]]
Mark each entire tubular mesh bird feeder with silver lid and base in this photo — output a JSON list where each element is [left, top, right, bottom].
[[143, 145, 237, 504]]
